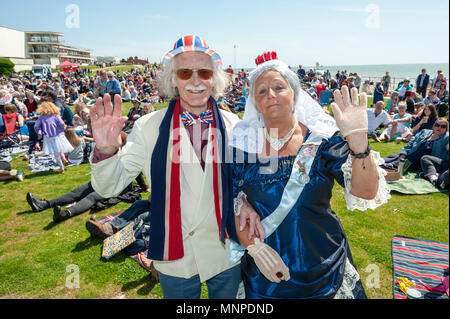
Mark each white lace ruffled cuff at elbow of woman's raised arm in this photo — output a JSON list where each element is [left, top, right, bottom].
[[342, 151, 391, 211]]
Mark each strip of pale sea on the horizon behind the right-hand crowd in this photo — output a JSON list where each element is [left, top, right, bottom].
[[238, 62, 450, 84]]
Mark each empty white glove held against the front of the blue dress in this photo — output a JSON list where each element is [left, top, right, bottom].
[[247, 238, 291, 283]]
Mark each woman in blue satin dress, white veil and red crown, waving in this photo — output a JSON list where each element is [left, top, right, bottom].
[[229, 52, 390, 299]]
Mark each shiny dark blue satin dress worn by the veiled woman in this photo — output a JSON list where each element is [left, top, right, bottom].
[[232, 133, 365, 299]]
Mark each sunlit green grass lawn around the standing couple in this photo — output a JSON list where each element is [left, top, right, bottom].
[[0, 103, 449, 299]]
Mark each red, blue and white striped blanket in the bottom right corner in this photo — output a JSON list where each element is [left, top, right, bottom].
[[392, 235, 449, 299]]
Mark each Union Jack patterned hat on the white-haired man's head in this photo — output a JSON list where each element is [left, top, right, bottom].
[[162, 35, 222, 66]]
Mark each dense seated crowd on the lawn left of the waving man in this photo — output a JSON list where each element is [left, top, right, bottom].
[[0, 63, 164, 180]]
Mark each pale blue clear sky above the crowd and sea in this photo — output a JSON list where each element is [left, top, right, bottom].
[[0, 0, 449, 67]]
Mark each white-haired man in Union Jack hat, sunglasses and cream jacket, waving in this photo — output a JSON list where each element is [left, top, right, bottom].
[[91, 36, 258, 299]]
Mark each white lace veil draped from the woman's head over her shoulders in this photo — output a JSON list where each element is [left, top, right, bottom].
[[228, 60, 338, 154]]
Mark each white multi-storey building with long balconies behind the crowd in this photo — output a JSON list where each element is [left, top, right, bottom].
[[0, 26, 93, 72]]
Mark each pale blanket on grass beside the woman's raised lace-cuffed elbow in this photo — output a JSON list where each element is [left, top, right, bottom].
[[387, 172, 446, 195]]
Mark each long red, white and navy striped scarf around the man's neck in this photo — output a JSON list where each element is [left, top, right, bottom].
[[148, 98, 238, 261]]
